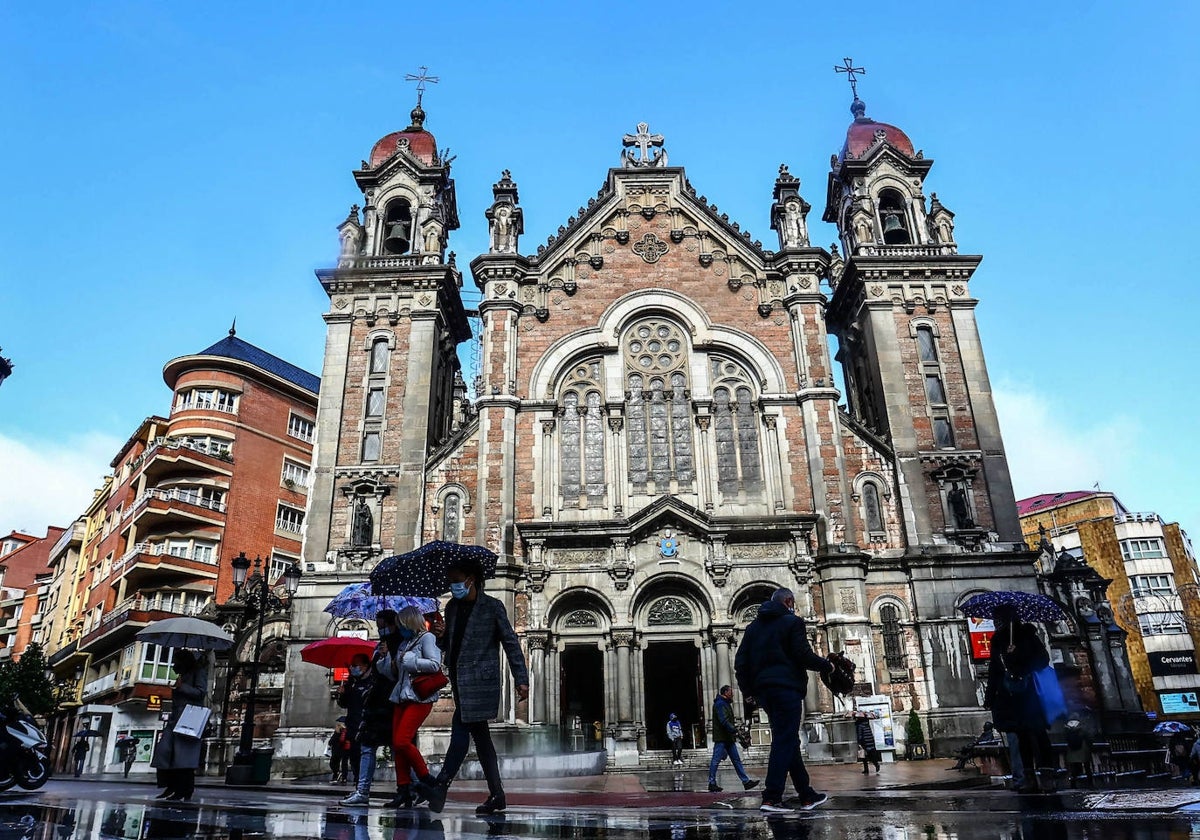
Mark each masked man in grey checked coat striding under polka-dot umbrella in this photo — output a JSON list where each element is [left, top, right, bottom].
[[422, 557, 529, 816]]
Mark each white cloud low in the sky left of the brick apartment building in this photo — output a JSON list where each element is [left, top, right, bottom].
[[0, 432, 124, 536]]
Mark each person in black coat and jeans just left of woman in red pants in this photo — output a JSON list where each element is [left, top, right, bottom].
[[338, 610, 400, 805]]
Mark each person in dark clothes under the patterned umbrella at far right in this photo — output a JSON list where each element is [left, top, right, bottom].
[[984, 605, 1057, 793]]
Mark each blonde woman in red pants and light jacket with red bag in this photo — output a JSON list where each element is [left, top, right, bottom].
[[379, 607, 442, 808]]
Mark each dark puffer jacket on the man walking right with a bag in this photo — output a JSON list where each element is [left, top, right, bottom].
[[733, 601, 833, 697]]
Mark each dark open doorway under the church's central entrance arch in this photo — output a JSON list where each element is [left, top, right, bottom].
[[642, 642, 703, 750]]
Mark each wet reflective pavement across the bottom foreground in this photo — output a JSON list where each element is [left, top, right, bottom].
[[0, 780, 1200, 840]]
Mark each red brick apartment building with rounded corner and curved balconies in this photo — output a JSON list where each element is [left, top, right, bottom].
[[52, 330, 318, 769]]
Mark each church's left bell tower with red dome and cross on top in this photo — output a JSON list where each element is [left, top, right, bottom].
[[304, 93, 470, 574]]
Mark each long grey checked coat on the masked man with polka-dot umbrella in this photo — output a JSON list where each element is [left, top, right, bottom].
[[438, 593, 529, 724]]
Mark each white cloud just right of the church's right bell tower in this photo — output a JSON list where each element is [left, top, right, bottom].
[[994, 382, 1142, 499]]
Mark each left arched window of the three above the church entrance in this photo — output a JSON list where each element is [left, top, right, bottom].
[[559, 359, 606, 503]]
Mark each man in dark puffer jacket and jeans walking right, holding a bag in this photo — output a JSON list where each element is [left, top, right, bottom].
[[733, 589, 834, 811]]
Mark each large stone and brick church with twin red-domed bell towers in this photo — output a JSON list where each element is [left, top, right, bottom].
[[280, 90, 1037, 766]]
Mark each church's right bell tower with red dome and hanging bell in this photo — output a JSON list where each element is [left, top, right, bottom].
[[823, 92, 1021, 551]]
